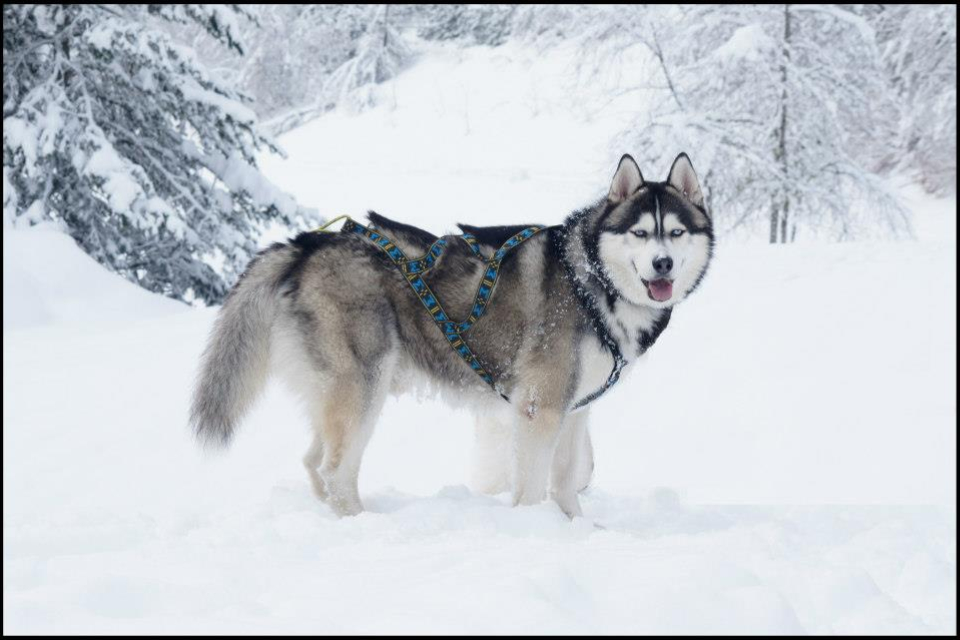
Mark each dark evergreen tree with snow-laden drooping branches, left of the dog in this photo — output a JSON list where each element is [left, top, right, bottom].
[[3, 4, 298, 302]]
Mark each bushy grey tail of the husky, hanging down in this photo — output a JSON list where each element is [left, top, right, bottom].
[[190, 247, 295, 447]]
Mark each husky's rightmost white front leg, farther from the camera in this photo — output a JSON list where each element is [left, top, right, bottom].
[[550, 410, 593, 518]]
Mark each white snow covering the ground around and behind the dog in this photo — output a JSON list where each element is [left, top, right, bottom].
[[3, 41, 957, 634]]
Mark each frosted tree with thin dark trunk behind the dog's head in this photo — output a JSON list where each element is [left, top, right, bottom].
[[608, 4, 909, 243]]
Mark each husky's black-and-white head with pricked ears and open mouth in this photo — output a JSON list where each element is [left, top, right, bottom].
[[596, 153, 713, 309]]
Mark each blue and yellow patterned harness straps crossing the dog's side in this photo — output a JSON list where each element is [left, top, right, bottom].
[[341, 218, 545, 401]]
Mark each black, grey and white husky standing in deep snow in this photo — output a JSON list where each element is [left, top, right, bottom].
[[191, 154, 713, 517]]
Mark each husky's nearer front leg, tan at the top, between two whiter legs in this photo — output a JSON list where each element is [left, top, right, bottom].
[[512, 400, 563, 506]]
